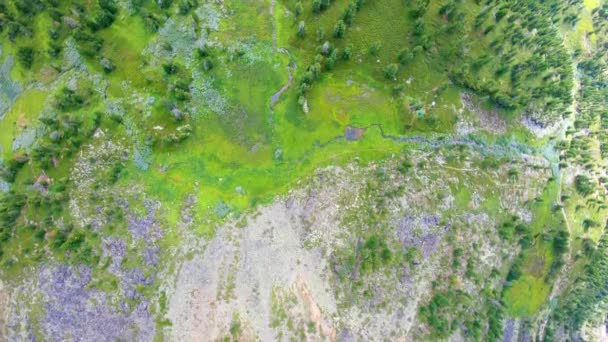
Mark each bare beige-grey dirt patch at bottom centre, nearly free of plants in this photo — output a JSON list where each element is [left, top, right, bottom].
[[168, 201, 336, 341]]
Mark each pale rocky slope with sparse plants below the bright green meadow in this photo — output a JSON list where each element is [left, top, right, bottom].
[[162, 153, 548, 341]]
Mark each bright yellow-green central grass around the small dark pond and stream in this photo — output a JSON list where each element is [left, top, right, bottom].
[[104, 1, 470, 235]]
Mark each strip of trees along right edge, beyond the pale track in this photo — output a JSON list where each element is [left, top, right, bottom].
[[546, 4, 608, 338]]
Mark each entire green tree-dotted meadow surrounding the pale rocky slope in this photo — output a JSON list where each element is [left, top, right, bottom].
[[0, 0, 608, 340]]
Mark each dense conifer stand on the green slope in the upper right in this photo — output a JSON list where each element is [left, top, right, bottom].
[[440, 0, 576, 122]]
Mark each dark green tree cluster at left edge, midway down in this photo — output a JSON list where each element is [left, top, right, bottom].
[[0, 105, 101, 264]]
